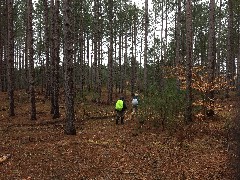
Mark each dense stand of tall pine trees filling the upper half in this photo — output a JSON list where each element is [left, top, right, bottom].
[[0, 0, 240, 129]]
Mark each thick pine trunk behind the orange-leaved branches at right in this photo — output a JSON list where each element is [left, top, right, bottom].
[[207, 0, 216, 116]]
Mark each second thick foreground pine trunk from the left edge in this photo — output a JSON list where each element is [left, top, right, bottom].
[[27, 0, 37, 120]]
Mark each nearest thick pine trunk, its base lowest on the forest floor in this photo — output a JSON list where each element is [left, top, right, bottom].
[[63, 0, 76, 135]]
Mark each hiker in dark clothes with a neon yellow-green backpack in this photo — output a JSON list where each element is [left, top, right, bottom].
[[115, 96, 127, 124]]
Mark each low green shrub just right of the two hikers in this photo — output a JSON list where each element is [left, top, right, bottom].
[[138, 79, 185, 128]]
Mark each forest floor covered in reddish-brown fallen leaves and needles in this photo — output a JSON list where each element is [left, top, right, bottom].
[[0, 92, 240, 180]]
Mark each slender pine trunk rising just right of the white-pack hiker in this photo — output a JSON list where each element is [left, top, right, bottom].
[[143, 0, 149, 93]]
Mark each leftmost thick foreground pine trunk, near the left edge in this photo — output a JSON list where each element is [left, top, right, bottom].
[[7, 0, 15, 116]]
